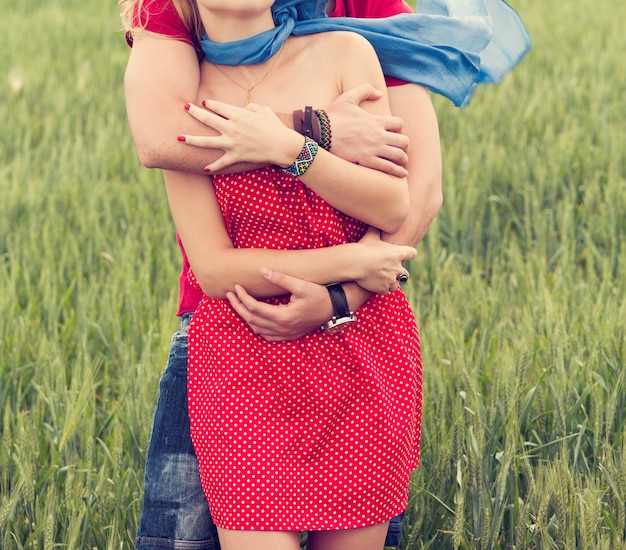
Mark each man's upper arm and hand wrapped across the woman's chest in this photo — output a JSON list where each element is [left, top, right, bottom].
[[124, 35, 408, 177]]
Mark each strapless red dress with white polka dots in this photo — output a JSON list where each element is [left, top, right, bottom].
[[188, 167, 422, 531]]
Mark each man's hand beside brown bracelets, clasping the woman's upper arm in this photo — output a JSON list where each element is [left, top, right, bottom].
[[326, 84, 409, 178]]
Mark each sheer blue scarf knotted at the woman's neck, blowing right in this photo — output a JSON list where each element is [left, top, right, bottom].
[[201, 0, 530, 106]]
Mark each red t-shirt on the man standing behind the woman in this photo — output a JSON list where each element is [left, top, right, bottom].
[[126, 0, 413, 315]]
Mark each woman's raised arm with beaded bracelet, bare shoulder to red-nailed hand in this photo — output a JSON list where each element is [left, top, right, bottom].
[[185, 32, 409, 232]]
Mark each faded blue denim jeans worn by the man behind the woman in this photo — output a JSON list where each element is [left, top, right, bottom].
[[136, 314, 402, 550]]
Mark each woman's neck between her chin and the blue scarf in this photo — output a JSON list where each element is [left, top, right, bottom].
[[198, 6, 275, 43]]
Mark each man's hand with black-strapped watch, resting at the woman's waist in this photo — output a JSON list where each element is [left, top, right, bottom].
[[226, 270, 333, 342]]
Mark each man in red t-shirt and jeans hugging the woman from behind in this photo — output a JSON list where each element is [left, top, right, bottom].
[[125, 0, 441, 550]]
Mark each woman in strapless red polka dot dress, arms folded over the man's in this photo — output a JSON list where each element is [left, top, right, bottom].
[[167, 0, 422, 550]]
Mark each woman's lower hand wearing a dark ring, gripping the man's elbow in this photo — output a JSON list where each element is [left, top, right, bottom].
[[355, 228, 417, 294]]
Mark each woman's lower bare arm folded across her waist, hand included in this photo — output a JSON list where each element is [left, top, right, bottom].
[[165, 172, 415, 298]]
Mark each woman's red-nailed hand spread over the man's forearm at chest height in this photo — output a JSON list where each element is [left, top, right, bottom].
[[179, 99, 303, 173]]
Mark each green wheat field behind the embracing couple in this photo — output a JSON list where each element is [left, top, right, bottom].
[[0, 0, 626, 550]]
